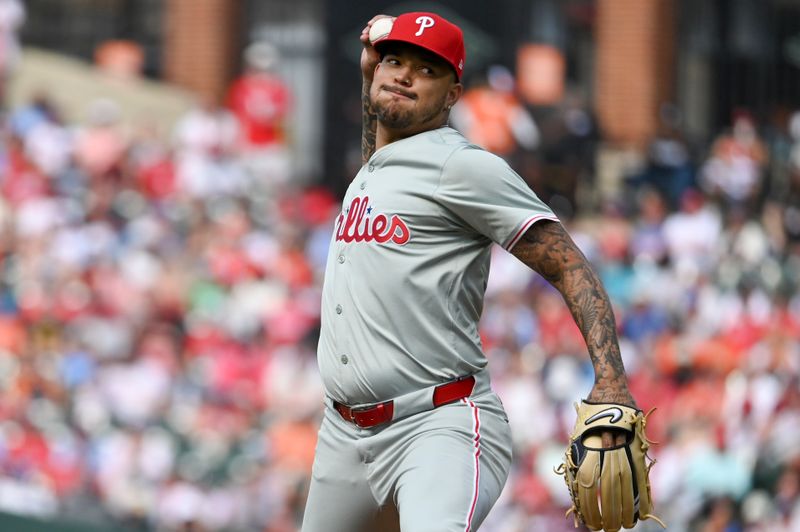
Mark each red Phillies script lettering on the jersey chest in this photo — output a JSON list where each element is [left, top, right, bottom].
[[336, 196, 411, 245]]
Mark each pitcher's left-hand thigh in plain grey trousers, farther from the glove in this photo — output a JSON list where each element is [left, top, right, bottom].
[[302, 412, 397, 532]]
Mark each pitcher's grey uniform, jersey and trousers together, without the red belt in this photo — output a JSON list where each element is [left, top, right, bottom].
[[303, 127, 556, 532]]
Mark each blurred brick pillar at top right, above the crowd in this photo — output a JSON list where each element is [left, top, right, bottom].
[[595, 0, 675, 147]]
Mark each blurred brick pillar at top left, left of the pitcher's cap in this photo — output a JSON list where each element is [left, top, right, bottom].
[[164, 0, 242, 103]]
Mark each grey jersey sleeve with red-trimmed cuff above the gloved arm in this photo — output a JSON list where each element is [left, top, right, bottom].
[[436, 147, 558, 250]]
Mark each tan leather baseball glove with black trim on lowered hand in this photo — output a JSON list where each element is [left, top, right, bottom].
[[556, 401, 666, 532]]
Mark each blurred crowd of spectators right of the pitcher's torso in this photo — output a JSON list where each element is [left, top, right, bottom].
[[482, 109, 800, 532]]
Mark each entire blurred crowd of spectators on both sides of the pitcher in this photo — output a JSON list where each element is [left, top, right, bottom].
[[0, 46, 800, 532]]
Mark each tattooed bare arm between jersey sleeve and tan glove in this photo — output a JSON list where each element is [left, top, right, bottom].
[[512, 221, 631, 404]]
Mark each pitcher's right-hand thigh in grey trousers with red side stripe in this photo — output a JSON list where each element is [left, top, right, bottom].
[[394, 394, 511, 532]]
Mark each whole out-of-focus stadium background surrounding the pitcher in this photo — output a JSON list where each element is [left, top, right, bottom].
[[0, 0, 800, 532]]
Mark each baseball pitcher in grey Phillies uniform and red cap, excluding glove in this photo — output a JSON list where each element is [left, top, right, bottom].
[[303, 13, 634, 532]]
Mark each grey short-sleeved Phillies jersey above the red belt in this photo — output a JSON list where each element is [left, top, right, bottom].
[[318, 127, 557, 405]]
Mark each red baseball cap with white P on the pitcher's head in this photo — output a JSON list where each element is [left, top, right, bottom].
[[375, 11, 466, 80]]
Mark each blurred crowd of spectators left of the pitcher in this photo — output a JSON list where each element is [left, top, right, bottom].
[[0, 42, 335, 531]]
